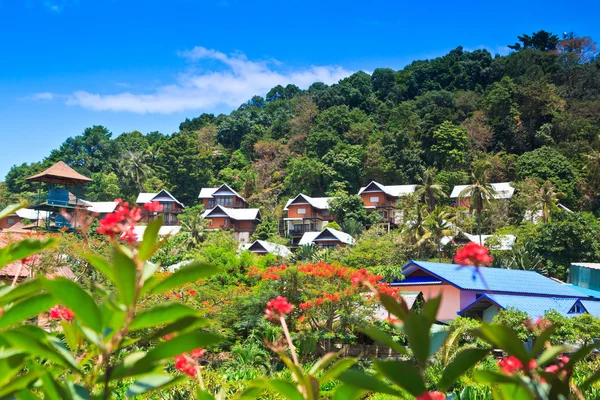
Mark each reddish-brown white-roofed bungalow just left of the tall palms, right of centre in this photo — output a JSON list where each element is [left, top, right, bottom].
[[358, 181, 417, 226]]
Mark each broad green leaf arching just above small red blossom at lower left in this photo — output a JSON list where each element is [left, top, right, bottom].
[[43, 278, 102, 333]]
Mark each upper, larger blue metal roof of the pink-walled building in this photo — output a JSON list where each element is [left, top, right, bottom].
[[395, 261, 587, 298]]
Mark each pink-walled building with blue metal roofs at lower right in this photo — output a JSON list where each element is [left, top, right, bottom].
[[391, 261, 590, 321]]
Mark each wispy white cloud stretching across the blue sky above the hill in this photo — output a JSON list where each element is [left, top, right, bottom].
[[30, 46, 352, 114]]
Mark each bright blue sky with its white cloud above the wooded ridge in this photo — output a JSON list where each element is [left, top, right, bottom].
[[0, 0, 600, 180]]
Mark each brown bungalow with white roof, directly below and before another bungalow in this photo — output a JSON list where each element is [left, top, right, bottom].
[[202, 205, 261, 243]]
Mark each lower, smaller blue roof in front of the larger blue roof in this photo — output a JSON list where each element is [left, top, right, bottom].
[[458, 294, 580, 318]]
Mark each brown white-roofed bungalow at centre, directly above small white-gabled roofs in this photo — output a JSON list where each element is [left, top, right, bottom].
[[283, 193, 335, 247]]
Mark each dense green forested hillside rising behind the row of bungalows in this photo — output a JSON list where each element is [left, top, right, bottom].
[[0, 31, 600, 222]]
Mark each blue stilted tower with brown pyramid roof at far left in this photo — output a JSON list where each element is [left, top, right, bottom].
[[26, 161, 92, 230]]
